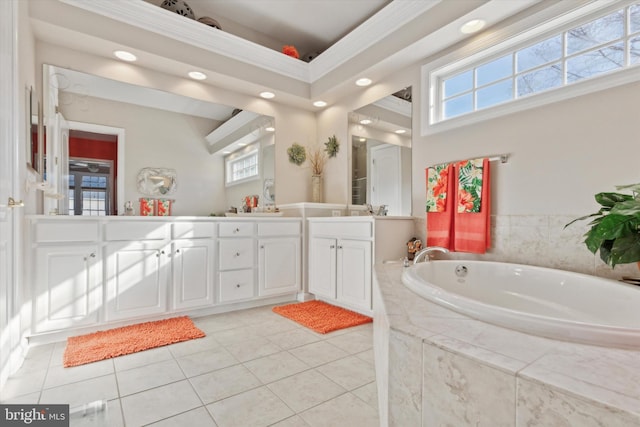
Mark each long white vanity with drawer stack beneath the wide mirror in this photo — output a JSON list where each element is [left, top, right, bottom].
[[25, 215, 302, 342]]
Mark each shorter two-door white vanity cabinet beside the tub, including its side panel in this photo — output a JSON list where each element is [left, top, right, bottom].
[[308, 217, 414, 314]]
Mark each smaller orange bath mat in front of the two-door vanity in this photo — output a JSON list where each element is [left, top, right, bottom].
[[273, 301, 373, 334]]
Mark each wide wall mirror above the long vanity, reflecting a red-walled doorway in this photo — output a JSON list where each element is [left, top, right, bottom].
[[43, 65, 275, 216]]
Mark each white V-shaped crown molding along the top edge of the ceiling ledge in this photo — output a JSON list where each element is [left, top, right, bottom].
[[58, 0, 442, 84]]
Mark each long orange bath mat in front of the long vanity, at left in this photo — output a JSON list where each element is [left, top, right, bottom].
[[63, 316, 205, 368]]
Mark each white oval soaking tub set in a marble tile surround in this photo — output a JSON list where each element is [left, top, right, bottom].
[[402, 260, 640, 349]]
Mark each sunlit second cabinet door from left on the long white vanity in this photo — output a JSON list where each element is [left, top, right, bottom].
[[105, 241, 170, 320]]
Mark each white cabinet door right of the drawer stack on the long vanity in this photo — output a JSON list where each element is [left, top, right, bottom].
[[258, 237, 300, 296]]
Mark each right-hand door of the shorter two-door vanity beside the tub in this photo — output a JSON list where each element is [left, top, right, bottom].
[[337, 240, 371, 310]]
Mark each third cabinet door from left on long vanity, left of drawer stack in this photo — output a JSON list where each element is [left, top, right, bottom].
[[171, 239, 215, 309]]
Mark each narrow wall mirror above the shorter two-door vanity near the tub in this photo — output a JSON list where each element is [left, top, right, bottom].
[[349, 87, 412, 216]]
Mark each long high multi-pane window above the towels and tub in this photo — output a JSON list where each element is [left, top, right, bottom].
[[430, 2, 640, 123]]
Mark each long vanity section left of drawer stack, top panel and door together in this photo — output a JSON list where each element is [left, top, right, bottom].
[[171, 221, 216, 310]]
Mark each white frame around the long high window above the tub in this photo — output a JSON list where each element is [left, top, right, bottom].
[[421, 0, 640, 135]]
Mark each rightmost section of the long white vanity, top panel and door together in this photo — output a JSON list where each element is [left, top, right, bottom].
[[258, 221, 302, 296]]
